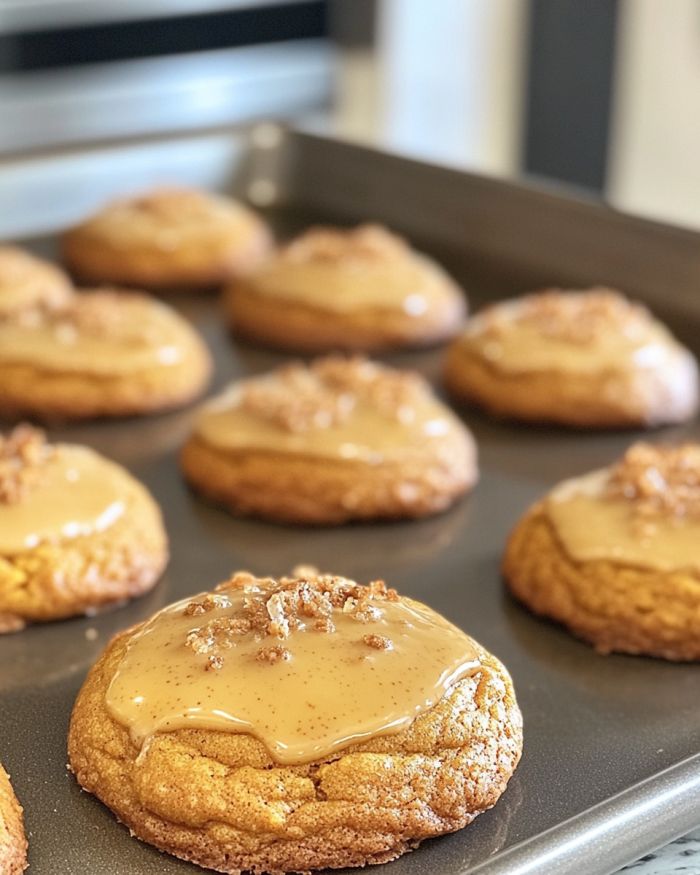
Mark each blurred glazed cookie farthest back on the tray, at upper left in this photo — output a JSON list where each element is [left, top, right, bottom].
[[62, 188, 271, 291]]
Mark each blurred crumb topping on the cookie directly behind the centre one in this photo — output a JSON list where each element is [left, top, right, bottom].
[[281, 224, 410, 264]]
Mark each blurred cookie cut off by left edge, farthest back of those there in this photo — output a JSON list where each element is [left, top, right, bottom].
[[0, 244, 73, 319]]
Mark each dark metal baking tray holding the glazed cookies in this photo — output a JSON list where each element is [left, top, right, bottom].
[[0, 125, 700, 875]]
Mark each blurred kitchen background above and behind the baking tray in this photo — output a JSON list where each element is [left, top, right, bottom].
[[0, 0, 700, 227]]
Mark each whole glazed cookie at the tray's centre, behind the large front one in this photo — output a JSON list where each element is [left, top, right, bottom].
[[181, 357, 477, 524]]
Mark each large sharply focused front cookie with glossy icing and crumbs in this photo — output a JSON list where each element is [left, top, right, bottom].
[[68, 569, 522, 875]]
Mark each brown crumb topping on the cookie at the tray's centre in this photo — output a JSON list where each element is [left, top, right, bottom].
[[240, 356, 427, 433]]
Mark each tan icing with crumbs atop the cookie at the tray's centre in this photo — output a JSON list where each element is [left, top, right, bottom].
[[195, 358, 460, 464]]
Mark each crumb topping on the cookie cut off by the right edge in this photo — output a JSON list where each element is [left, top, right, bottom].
[[607, 443, 700, 520]]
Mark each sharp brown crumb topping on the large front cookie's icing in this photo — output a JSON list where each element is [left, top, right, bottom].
[[183, 568, 399, 670]]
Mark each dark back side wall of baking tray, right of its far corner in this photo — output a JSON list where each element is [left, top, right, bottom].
[[270, 126, 700, 326]]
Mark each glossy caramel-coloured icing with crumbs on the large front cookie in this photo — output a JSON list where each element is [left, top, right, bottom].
[[107, 573, 478, 764]]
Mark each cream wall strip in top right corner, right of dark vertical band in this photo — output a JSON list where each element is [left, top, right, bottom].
[[608, 0, 700, 227]]
